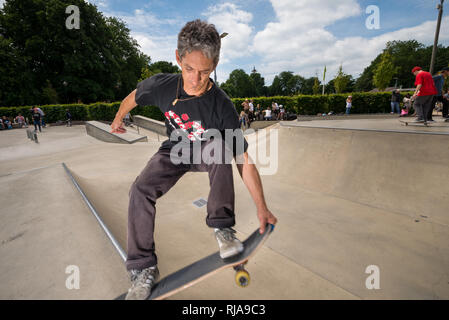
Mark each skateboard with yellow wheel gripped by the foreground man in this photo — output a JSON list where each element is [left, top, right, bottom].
[[116, 224, 274, 300]]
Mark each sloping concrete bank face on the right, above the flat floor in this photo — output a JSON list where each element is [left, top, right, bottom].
[[276, 122, 449, 226]]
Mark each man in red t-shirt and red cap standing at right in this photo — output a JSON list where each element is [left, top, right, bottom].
[[412, 67, 437, 123]]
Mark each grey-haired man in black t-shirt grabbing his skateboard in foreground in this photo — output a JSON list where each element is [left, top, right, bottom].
[[111, 20, 277, 299]]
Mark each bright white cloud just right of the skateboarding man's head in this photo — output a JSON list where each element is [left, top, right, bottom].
[[203, 2, 254, 64]]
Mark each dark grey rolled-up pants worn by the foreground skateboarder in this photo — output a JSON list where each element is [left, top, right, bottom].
[[126, 142, 235, 270]]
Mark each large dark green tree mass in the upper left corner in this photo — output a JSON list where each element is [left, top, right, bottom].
[[0, 0, 149, 106]]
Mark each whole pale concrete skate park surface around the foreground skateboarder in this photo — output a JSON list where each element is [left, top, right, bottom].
[[0, 116, 449, 300]]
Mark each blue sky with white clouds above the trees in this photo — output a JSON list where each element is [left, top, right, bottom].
[[0, 0, 449, 85]]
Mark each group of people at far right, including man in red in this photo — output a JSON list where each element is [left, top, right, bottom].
[[391, 67, 449, 122]]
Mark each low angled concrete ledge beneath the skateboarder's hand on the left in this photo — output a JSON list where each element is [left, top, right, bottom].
[[86, 121, 148, 144]]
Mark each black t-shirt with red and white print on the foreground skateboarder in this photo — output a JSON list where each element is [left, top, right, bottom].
[[136, 73, 248, 155]]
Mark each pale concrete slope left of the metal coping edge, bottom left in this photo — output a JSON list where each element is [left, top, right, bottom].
[[0, 164, 128, 299]]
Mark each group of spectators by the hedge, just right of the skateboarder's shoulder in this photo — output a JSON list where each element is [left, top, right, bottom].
[[239, 99, 285, 128]]
